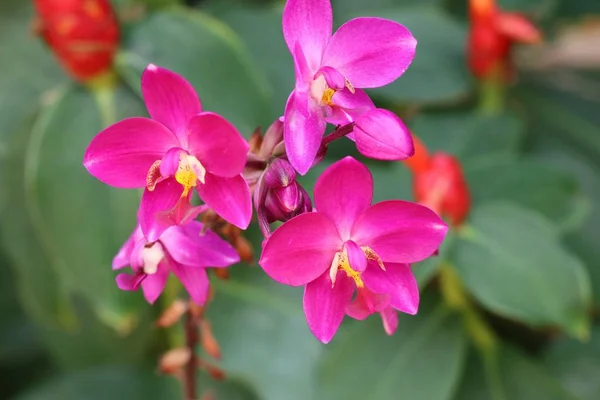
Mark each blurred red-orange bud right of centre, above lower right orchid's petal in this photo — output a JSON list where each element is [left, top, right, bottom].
[[413, 153, 471, 226]]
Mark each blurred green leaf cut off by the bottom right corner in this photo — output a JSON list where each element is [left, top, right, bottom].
[[544, 325, 600, 400]]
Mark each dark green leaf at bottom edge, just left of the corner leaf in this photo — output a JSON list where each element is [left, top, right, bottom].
[[454, 345, 576, 400]]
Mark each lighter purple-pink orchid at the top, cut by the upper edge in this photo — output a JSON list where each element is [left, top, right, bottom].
[[283, 0, 417, 174]]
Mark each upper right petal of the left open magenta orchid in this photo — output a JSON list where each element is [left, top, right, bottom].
[[189, 112, 249, 178]]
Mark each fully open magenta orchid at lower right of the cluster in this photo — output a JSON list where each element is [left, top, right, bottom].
[[259, 157, 448, 343]]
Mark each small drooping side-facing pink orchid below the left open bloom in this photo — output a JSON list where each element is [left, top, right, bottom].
[[113, 221, 240, 305]]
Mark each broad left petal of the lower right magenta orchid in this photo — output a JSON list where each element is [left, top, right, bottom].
[[259, 212, 342, 286]]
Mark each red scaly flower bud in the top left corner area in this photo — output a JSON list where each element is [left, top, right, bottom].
[[34, 0, 120, 82]]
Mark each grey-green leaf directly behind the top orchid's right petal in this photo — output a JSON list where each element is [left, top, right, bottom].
[[344, 7, 471, 103]]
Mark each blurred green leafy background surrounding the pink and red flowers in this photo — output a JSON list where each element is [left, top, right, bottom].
[[0, 0, 600, 400]]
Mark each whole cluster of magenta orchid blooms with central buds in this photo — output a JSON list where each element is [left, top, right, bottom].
[[83, 0, 447, 343]]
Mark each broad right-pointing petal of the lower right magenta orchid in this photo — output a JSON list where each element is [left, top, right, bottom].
[[352, 200, 448, 264]]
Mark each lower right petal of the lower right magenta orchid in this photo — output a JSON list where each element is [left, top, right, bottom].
[[362, 263, 419, 315]]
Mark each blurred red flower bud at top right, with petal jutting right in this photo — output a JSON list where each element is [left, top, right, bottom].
[[467, 0, 541, 81]]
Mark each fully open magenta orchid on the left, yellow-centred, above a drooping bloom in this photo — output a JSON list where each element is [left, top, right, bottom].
[[83, 64, 252, 241]]
